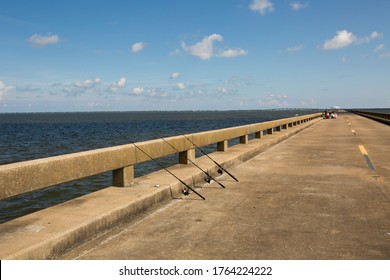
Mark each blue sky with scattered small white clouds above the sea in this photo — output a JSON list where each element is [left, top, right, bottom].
[[0, 0, 390, 112]]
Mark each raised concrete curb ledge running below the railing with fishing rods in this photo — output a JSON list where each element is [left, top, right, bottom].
[[0, 118, 321, 260]]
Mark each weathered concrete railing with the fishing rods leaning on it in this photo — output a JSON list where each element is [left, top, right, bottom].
[[0, 113, 321, 199]]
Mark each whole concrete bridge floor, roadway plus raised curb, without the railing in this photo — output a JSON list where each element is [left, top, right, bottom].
[[0, 113, 390, 260]]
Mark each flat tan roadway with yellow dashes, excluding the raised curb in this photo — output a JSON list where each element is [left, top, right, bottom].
[[64, 114, 390, 260]]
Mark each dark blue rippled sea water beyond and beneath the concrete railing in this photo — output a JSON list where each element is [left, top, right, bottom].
[[0, 110, 315, 223]]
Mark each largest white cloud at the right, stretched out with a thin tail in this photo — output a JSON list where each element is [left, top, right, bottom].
[[322, 30, 383, 50]]
